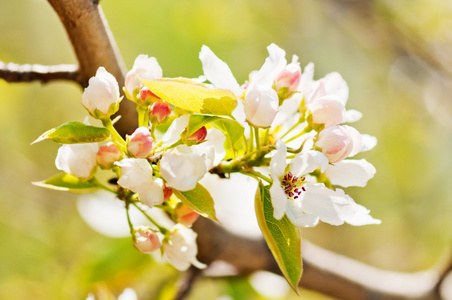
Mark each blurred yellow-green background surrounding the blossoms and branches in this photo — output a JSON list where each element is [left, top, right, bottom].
[[0, 0, 452, 299]]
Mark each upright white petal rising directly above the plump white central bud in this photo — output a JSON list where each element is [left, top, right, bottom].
[[249, 44, 287, 87]]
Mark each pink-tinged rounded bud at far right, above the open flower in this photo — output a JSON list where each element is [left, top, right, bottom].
[[315, 125, 361, 163]]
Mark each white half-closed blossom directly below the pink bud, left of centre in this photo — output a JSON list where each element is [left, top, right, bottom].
[[115, 158, 163, 207]]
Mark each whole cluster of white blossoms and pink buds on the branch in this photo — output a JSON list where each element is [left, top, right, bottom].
[[36, 44, 380, 276]]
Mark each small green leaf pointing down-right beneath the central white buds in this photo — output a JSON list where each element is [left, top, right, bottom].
[[173, 183, 218, 221]]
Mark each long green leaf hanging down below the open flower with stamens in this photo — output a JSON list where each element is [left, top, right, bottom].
[[255, 182, 303, 294]]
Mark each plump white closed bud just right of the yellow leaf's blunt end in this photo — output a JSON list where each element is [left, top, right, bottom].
[[245, 86, 279, 128]]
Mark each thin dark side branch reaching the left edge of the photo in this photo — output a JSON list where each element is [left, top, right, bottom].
[[0, 61, 80, 83]]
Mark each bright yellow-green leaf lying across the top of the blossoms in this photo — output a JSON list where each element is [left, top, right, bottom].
[[142, 78, 237, 115]]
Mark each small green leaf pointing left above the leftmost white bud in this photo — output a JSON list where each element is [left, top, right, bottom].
[[32, 122, 110, 144]]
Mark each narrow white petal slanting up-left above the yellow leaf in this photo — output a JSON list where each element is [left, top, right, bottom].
[[199, 46, 242, 96]]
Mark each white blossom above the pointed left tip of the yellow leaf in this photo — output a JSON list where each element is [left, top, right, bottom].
[[125, 54, 163, 96]]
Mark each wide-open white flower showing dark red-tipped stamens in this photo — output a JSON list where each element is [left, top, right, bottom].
[[270, 141, 380, 227]]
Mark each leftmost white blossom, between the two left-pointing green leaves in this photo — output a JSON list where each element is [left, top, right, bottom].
[[55, 143, 98, 179]]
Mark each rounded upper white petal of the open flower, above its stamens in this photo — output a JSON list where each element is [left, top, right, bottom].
[[290, 150, 328, 177]]
